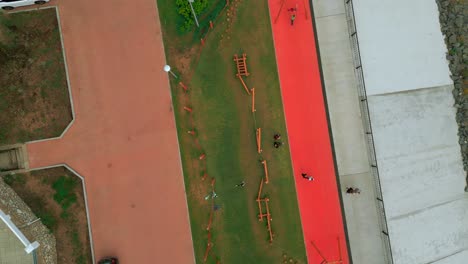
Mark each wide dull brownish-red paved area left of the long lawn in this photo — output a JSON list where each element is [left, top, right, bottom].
[[27, 0, 194, 264]]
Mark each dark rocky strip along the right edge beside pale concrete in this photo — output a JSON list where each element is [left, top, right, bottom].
[[436, 0, 468, 192]]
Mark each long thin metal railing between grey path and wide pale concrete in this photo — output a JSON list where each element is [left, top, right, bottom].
[[344, 0, 393, 264]]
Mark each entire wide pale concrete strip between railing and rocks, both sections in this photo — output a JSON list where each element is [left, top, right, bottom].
[[352, 0, 468, 264]]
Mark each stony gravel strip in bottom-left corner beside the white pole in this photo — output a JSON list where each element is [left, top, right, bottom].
[[0, 177, 57, 264]]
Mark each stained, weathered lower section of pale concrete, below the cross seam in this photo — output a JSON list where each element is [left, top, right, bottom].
[[368, 85, 468, 264]]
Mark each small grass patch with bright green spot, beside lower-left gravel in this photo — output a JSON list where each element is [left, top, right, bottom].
[[3, 167, 92, 264]]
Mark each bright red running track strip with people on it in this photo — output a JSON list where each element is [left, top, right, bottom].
[[268, 0, 349, 264]]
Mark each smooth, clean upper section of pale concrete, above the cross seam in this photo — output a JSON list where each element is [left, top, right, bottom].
[[353, 0, 452, 95]]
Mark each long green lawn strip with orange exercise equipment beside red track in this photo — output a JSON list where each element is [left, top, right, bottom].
[[157, 0, 306, 263]]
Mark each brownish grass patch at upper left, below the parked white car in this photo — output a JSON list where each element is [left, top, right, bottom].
[[0, 8, 72, 145]]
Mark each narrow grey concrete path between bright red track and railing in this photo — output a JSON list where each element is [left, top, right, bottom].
[[312, 0, 385, 264]]
